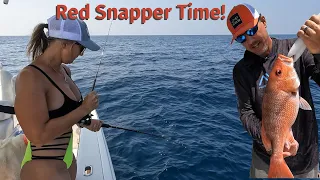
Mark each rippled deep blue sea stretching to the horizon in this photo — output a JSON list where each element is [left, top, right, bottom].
[[0, 35, 320, 180]]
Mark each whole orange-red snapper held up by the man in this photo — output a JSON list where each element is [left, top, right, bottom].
[[261, 54, 311, 178]]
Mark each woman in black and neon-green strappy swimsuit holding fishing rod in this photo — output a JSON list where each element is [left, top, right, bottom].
[[15, 16, 102, 180]]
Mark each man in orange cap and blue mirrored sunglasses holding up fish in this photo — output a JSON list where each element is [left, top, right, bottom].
[[227, 4, 320, 178]]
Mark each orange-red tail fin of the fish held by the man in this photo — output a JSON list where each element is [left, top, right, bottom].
[[268, 153, 293, 178]]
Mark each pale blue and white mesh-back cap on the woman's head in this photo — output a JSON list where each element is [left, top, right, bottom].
[[47, 15, 100, 51]]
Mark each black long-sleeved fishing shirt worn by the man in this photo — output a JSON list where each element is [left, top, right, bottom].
[[233, 38, 320, 175]]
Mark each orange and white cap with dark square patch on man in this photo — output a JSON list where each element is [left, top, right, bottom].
[[227, 3, 259, 43]]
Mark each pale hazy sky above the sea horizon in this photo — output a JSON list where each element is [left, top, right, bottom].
[[0, 0, 320, 36]]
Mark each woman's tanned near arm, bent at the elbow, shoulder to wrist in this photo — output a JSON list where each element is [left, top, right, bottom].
[[14, 68, 90, 146]]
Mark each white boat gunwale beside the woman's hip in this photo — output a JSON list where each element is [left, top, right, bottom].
[[73, 111, 116, 180]]
